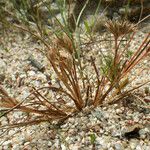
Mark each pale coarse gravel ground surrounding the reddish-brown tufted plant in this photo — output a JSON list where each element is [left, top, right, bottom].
[[0, 24, 150, 150]]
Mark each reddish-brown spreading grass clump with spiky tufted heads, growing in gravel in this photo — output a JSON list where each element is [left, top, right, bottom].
[[0, 0, 150, 128]]
